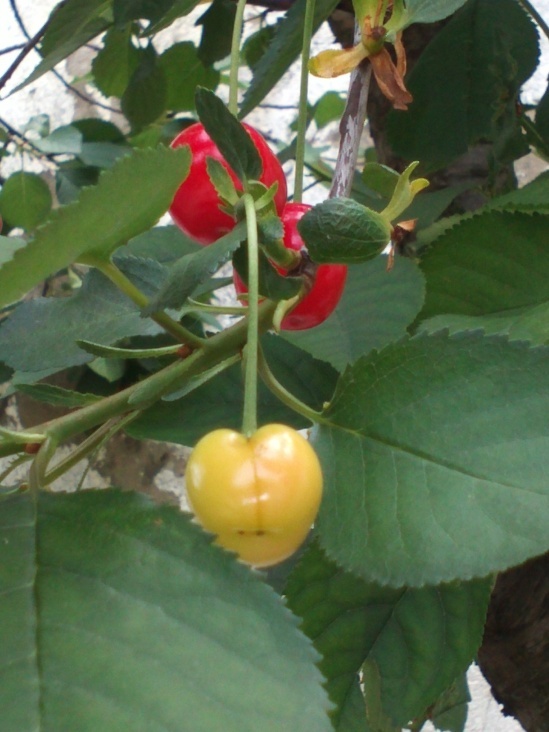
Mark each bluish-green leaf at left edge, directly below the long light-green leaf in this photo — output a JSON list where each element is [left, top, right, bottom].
[[0, 259, 166, 378]]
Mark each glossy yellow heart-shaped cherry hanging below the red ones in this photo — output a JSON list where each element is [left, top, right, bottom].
[[185, 424, 322, 567]]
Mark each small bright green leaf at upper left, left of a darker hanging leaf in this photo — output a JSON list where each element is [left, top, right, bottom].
[[92, 26, 140, 97]]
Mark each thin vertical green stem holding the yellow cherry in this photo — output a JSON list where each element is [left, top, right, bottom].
[[242, 193, 259, 437]]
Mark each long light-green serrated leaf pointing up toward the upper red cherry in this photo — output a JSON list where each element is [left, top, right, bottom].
[[0, 148, 189, 308]]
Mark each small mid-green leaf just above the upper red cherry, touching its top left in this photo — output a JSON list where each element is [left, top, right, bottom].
[[158, 42, 219, 112]]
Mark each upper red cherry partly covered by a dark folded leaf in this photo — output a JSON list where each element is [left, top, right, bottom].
[[170, 122, 287, 244]]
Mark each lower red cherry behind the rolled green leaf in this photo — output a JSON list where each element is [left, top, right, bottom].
[[233, 203, 347, 330]]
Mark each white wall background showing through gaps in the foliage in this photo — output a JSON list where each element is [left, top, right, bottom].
[[0, 0, 549, 732]]
